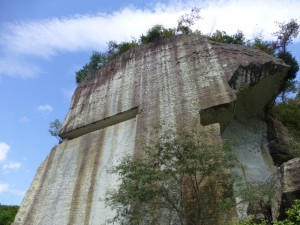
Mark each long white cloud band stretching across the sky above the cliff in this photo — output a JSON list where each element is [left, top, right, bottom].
[[0, 0, 300, 78]]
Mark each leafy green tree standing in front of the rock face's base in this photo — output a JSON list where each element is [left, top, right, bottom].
[[106, 128, 234, 225]]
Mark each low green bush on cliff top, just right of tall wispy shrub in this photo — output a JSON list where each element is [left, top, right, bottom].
[[210, 30, 245, 45]]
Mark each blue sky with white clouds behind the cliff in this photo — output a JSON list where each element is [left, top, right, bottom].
[[0, 0, 300, 205]]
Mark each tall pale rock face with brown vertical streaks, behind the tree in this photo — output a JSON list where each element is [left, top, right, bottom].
[[14, 35, 288, 225]]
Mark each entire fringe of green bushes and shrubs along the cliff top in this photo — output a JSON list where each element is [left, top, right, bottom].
[[76, 7, 299, 100]]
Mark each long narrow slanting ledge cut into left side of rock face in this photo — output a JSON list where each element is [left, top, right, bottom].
[[59, 107, 138, 139]]
